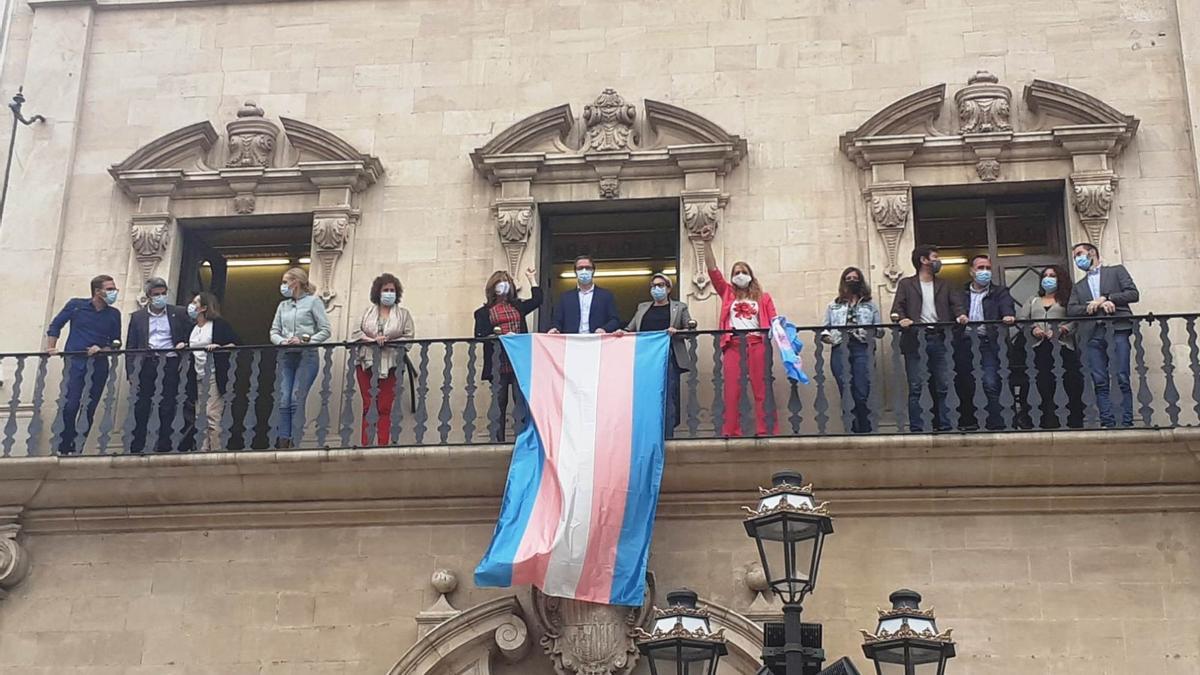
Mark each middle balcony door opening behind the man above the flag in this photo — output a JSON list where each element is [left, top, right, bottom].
[[538, 199, 679, 330]]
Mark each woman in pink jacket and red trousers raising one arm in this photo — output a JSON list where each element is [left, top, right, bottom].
[[704, 243, 775, 437]]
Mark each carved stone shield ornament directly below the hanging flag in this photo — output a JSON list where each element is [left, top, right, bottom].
[[533, 583, 653, 675]]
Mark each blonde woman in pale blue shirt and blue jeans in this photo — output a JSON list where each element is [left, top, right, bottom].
[[271, 267, 332, 449]]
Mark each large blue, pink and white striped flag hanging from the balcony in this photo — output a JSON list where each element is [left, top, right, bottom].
[[475, 333, 671, 605]]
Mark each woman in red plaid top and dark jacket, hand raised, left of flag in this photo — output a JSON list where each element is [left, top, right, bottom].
[[475, 268, 542, 443]]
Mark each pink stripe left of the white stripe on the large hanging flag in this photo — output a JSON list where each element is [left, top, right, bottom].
[[512, 335, 566, 586]]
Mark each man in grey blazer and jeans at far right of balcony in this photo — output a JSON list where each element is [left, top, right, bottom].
[[1067, 243, 1139, 428]]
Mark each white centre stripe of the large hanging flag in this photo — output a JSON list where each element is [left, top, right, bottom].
[[542, 335, 600, 597]]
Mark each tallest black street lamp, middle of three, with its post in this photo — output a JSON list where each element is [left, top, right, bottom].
[[744, 471, 833, 675]]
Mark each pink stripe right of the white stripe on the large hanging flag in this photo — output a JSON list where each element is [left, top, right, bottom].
[[575, 339, 637, 603]]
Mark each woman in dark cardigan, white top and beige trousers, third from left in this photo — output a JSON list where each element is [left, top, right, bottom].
[[187, 293, 240, 452]]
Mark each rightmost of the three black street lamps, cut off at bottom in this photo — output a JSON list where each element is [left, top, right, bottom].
[[863, 589, 954, 675]]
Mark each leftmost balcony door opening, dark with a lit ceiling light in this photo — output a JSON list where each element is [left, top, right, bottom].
[[175, 214, 312, 450]]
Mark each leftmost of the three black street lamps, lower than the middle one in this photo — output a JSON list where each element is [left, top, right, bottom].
[[637, 589, 728, 675]]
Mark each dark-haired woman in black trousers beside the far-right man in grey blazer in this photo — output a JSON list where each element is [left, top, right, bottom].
[[1016, 265, 1084, 429]]
